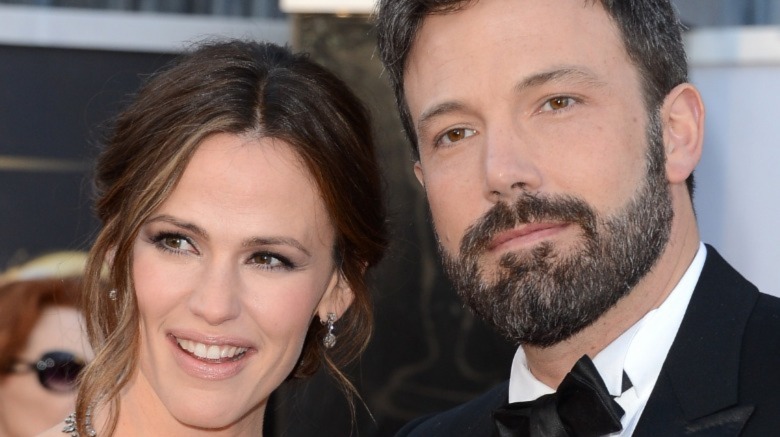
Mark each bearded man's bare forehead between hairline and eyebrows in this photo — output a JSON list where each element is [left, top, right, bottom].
[[404, 0, 630, 105]]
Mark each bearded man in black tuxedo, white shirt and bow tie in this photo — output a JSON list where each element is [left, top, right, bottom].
[[377, 0, 780, 436]]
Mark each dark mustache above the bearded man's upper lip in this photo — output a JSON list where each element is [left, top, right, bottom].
[[460, 193, 597, 258]]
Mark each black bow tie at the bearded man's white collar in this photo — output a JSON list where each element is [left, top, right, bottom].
[[493, 355, 624, 437]]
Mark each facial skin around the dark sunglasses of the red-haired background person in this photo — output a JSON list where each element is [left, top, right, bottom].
[[0, 306, 92, 437]]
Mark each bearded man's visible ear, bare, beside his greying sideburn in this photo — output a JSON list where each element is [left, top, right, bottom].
[[661, 83, 704, 184]]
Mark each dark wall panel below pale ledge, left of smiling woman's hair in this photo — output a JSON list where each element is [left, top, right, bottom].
[[0, 46, 172, 270]]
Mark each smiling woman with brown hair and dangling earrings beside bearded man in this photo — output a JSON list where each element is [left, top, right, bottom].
[[45, 41, 386, 436]]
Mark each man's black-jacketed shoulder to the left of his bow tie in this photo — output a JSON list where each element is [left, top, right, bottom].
[[396, 381, 509, 437]]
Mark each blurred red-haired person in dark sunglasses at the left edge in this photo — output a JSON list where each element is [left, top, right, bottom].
[[0, 252, 91, 437]]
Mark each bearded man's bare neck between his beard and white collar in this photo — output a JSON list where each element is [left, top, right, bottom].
[[523, 206, 699, 387]]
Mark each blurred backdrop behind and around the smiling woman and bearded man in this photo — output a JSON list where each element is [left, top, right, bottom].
[[0, 0, 780, 437]]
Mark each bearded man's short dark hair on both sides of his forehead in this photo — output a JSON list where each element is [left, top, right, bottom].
[[376, 0, 693, 195]]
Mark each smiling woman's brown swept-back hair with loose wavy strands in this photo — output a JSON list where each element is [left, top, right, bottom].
[[77, 40, 387, 435]]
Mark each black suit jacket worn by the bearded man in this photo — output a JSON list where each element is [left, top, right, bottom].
[[397, 246, 780, 437]]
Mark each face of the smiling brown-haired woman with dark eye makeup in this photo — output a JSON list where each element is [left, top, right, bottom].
[[127, 134, 352, 435]]
